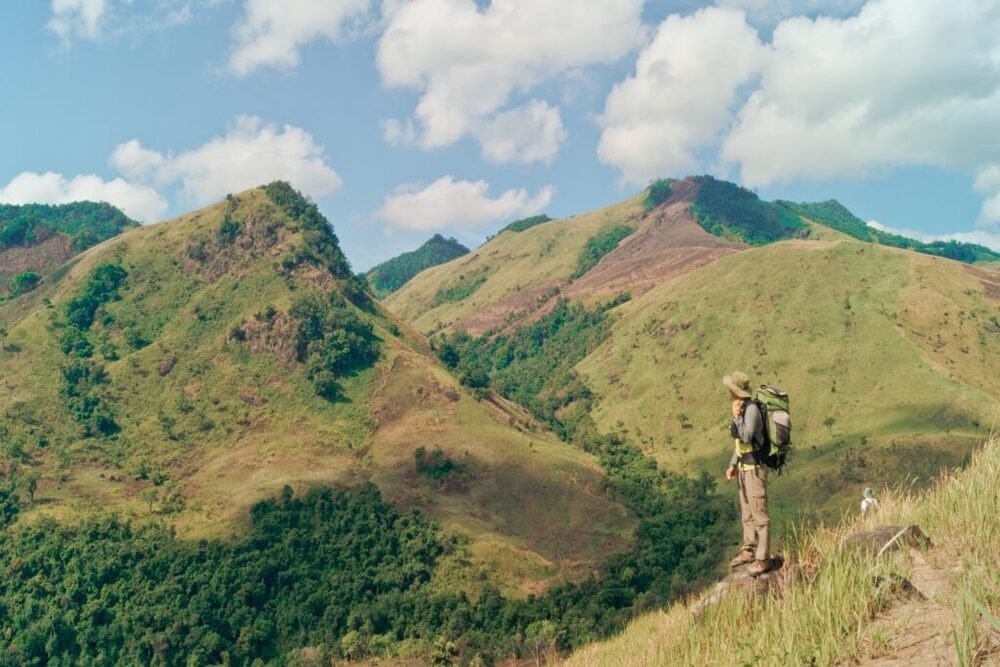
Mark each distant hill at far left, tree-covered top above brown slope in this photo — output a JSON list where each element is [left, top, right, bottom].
[[0, 202, 139, 299]]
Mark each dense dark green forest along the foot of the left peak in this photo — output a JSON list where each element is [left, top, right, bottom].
[[0, 470, 717, 665]]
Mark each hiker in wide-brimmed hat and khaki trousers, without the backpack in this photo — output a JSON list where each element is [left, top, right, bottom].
[[722, 371, 771, 577]]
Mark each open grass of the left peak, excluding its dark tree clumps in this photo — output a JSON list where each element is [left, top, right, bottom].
[[0, 191, 632, 591]]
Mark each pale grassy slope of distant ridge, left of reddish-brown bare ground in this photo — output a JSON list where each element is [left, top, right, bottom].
[[385, 192, 645, 333]]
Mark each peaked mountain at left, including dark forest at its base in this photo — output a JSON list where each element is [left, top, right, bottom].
[[0, 183, 752, 664]]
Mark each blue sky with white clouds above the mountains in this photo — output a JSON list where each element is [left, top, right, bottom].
[[0, 0, 1000, 269]]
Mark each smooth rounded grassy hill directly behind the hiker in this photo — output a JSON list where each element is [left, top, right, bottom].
[[578, 242, 1000, 517]]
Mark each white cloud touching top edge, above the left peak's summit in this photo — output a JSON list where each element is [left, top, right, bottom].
[[229, 0, 372, 76]]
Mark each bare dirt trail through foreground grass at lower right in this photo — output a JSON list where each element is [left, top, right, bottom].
[[860, 548, 959, 667]]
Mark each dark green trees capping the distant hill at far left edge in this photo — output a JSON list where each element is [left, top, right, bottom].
[[0, 201, 139, 252]]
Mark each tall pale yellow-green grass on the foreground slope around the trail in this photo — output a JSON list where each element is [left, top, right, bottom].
[[568, 438, 1000, 666]]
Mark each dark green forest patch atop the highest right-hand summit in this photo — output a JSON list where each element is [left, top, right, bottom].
[[691, 176, 808, 246]]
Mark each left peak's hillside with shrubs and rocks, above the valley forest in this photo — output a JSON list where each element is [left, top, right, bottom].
[[0, 186, 633, 594]]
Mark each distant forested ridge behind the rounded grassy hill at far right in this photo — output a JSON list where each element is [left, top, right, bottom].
[[775, 199, 1000, 264]]
